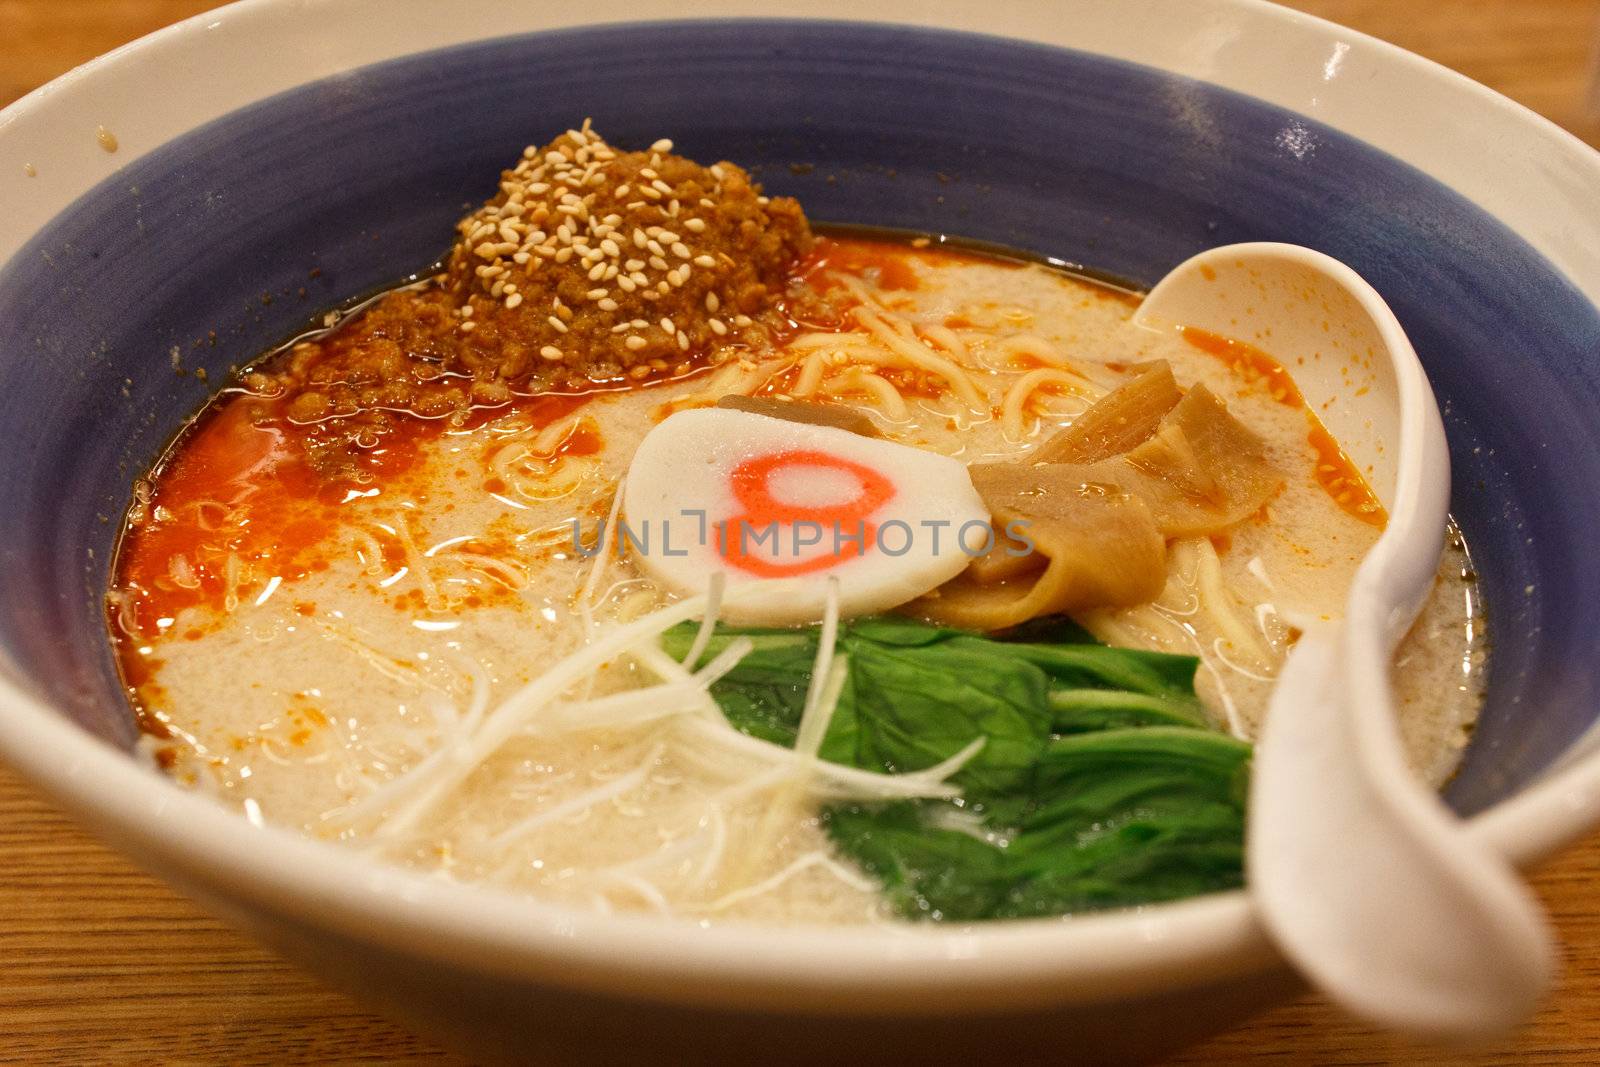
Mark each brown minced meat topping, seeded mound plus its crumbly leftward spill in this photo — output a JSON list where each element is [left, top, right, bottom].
[[246, 122, 813, 470]]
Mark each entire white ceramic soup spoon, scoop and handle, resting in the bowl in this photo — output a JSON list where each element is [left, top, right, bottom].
[[1134, 243, 1554, 1040]]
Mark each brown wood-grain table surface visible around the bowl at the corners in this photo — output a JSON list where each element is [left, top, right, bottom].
[[0, 0, 1600, 1067]]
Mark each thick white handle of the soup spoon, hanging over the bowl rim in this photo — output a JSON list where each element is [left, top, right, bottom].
[[1246, 627, 1554, 1040]]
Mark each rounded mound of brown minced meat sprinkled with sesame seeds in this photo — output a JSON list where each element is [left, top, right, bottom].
[[446, 123, 811, 378]]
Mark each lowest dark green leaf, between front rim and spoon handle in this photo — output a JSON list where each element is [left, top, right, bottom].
[[824, 728, 1250, 921]]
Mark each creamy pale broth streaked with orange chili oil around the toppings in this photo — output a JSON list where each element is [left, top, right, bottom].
[[114, 238, 1483, 923]]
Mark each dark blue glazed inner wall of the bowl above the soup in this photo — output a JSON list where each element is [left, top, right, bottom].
[[0, 21, 1600, 813]]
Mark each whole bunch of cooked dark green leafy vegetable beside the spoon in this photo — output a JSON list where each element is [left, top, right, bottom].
[[662, 617, 1250, 921]]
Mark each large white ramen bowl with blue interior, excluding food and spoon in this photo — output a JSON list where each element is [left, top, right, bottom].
[[0, 0, 1600, 1062]]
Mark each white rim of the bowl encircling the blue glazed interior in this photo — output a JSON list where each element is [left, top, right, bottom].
[[0, 0, 1600, 1014]]
